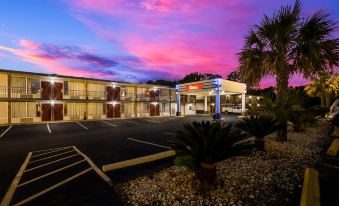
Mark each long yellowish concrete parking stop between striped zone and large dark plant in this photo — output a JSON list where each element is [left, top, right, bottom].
[[102, 150, 176, 172]]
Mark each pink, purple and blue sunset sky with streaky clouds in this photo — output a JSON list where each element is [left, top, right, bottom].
[[0, 0, 339, 87]]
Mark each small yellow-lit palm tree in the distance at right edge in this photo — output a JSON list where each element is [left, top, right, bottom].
[[305, 73, 339, 107]]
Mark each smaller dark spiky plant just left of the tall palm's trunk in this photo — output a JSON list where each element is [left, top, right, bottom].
[[235, 114, 281, 150]]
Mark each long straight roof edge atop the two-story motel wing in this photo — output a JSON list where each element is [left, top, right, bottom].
[[0, 68, 173, 89]]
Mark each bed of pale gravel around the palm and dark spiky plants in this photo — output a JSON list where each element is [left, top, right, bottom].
[[116, 121, 327, 206]]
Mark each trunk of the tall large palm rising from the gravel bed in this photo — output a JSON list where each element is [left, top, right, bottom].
[[277, 69, 289, 141]]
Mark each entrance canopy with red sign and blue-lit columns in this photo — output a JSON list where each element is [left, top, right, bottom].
[[176, 79, 246, 119]]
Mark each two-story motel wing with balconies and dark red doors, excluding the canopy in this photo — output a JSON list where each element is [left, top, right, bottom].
[[0, 70, 176, 124]]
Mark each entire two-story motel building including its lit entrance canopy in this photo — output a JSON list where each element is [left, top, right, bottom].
[[0, 69, 260, 124]]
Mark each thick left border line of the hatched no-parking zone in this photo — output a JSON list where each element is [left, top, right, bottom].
[[0, 152, 32, 206]]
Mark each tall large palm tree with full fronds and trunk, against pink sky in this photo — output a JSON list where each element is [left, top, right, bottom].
[[239, 0, 339, 141]]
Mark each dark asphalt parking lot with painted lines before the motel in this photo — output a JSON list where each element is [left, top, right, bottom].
[[0, 115, 237, 205]]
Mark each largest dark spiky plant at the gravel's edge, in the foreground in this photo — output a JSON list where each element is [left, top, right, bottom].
[[169, 121, 248, 183]]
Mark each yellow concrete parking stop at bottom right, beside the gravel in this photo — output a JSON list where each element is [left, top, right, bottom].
[[300, 168, 320, 206]]
